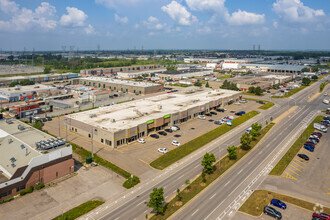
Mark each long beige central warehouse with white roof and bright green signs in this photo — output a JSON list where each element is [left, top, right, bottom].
[[66, 89, 241, 148]]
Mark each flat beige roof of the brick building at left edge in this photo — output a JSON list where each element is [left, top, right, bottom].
[[0, 119, 65, 183]]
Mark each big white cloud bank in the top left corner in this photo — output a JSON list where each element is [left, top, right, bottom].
[[0, 0, 57, 31]]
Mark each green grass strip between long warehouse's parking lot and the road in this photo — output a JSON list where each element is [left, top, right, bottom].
[[150, 111, 259, 170]]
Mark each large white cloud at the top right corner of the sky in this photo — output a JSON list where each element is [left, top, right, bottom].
[[273, 0, 325, 22]]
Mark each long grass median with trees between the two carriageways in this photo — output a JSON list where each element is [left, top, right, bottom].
[[151, 123, 274, 220]]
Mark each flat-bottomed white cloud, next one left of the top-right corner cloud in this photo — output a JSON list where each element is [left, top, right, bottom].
[[227, 9, 265, 25]]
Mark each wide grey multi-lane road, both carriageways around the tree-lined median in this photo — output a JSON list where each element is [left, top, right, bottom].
[[83, 76, 323, 220]]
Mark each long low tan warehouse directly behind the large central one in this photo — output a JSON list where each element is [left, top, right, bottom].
[[73, 77, 164, 95]]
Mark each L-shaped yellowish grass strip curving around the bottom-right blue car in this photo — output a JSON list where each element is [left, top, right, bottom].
[[239, 190, 330, 216]]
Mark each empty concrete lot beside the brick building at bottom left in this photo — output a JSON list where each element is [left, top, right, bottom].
[[0, 166, 125, 220]]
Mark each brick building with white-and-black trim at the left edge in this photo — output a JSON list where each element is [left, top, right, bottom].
[[0, 119, 74, 200]]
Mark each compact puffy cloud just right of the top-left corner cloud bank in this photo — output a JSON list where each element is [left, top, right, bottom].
[[60, 7, 88, 27]]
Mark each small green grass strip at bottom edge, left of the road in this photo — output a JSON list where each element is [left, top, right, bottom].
[[53, 200, 104, 220]]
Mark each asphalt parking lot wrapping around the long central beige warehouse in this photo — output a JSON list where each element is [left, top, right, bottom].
[[44, 101, 261, 180]]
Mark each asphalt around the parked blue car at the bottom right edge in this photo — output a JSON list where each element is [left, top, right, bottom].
[[232, 203, 313, 220]]
